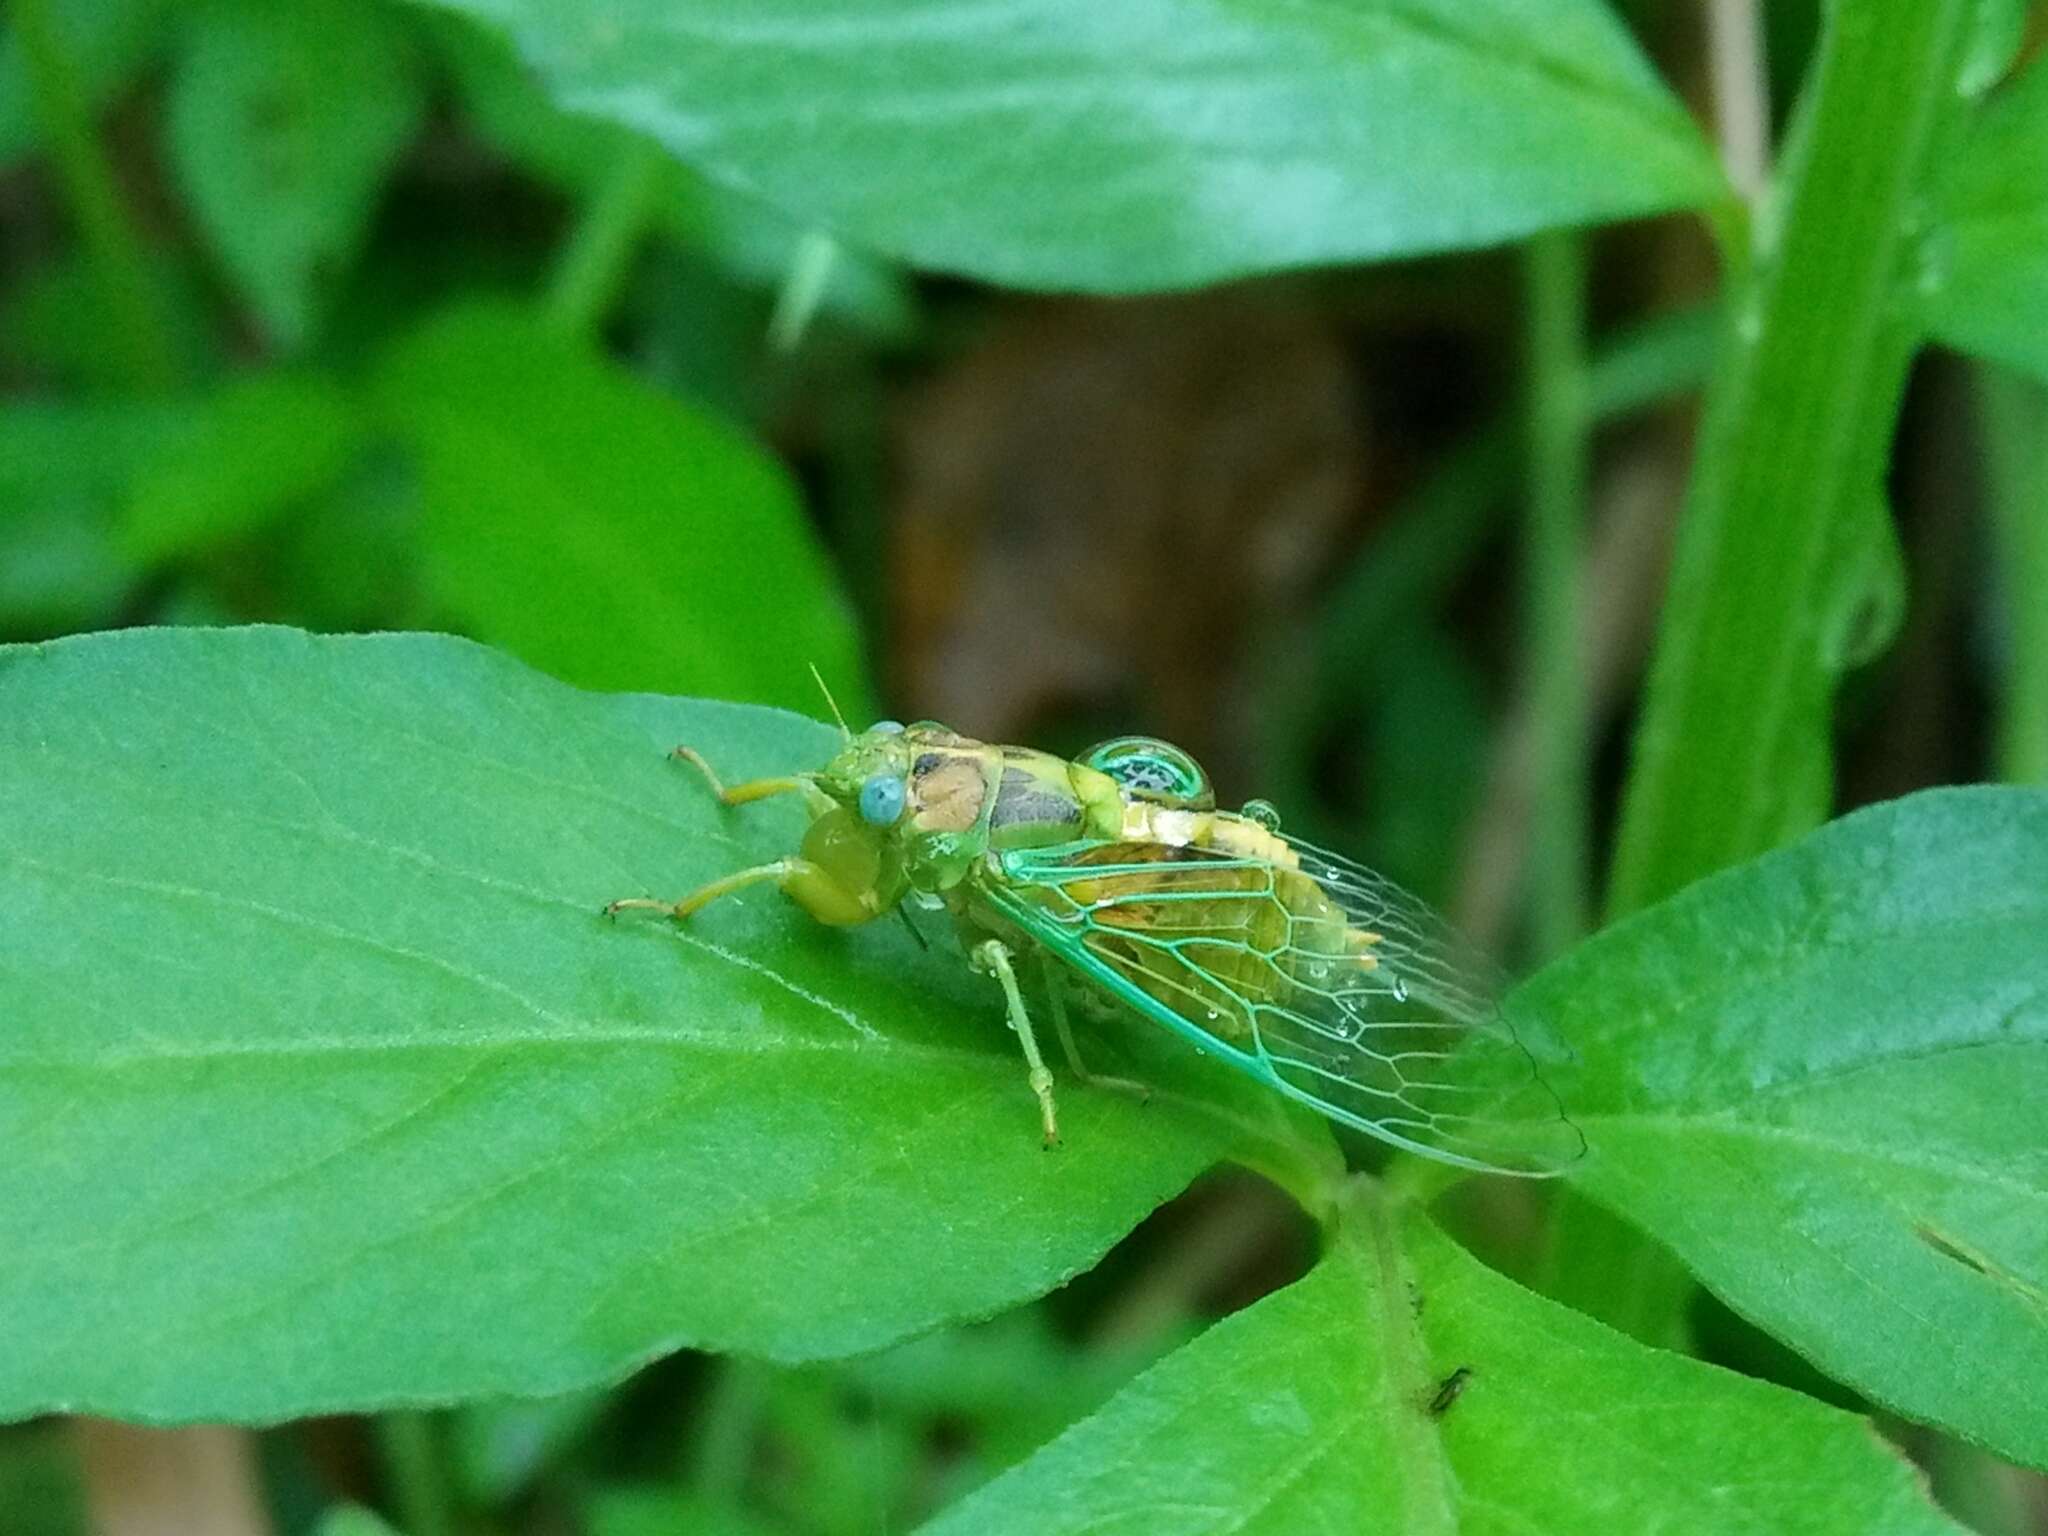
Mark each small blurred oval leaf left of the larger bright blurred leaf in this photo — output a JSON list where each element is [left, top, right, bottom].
[[121, 373, 362, 565]]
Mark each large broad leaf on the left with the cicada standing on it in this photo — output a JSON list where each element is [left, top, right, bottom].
[[0, 629, 1329, 1419]]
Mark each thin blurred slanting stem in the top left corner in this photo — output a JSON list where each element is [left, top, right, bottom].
[[14, 0, 176, 391]]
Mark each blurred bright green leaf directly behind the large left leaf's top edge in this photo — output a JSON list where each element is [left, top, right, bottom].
[[379, 309, 870, 719]]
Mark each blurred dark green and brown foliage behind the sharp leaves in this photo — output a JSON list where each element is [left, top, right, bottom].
[[0, 0, 2048, 1536]]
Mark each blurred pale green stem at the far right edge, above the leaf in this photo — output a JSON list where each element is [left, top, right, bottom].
[[1978, 369, 2048, 784]]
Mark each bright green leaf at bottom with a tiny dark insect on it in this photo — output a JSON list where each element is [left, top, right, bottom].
[[924, 1198, 1956, 1536]]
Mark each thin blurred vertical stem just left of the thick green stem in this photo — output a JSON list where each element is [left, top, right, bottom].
[[1522, 229, 1591, 958]]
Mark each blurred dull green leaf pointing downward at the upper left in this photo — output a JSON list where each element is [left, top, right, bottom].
[[166, 0, 426, 350]]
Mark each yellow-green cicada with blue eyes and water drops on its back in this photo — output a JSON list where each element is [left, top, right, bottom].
[[606, 721, 1583, 1174]]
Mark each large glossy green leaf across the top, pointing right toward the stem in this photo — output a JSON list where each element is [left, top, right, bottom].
[[407, 0, 1722, 291]]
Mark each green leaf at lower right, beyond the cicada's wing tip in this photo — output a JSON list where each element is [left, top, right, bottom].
[[1540, 788, 2048, 1466]]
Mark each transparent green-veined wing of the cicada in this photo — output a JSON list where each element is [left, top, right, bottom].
[[974, 842, 1585, 1176]]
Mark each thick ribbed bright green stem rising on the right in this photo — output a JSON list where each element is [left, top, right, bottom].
[[1610, 0, 1972, 913]]
